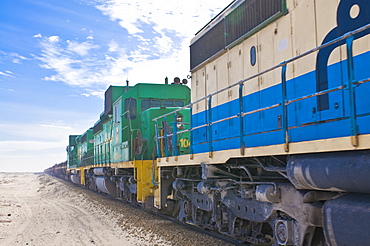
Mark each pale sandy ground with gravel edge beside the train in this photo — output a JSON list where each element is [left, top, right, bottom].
[[0, 173, 230, 246]]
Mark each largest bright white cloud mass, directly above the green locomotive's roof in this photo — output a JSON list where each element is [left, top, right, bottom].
[[35, 0, 229, 97]]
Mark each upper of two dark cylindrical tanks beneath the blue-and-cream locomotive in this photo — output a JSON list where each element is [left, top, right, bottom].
[[287, 150, 370, 193]]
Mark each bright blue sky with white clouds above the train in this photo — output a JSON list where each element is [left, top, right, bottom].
[[0, 0, 231, 172]]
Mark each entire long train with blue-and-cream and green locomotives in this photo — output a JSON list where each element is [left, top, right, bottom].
[[47, 0, 370, 246]]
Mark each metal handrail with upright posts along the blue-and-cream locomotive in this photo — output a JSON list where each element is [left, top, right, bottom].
[[152, 24, 370, 157]]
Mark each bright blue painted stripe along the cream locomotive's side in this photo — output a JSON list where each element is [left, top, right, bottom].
[[192, 52, 370, 153]]
